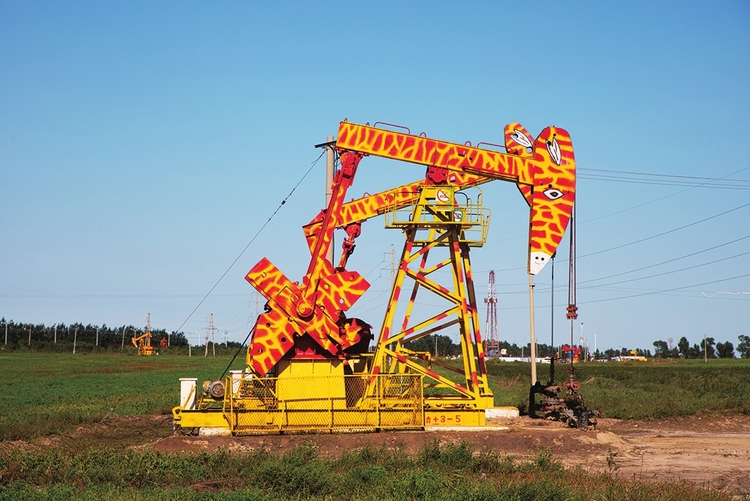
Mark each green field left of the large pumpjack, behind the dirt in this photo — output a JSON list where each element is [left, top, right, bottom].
[[0, 353, 234, 440]]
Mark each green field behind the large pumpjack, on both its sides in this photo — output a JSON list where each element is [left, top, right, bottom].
[[0, 352, 750, 440]]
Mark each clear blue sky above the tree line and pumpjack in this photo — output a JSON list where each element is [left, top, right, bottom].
[[0, 1, 750, 349]]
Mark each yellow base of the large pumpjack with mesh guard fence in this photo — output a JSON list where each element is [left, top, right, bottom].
[[172, 370, 508, 435]]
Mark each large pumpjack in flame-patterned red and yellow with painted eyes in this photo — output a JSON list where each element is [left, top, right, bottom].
[[173, 121, 575, 435]]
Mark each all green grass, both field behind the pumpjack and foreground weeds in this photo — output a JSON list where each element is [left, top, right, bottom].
[[0, 352, 750, 501]]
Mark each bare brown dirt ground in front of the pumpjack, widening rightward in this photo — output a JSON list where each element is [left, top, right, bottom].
[[145, 416, 750, 494]]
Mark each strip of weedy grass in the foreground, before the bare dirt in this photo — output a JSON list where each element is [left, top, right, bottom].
[[0, 442, 731, 501]]
